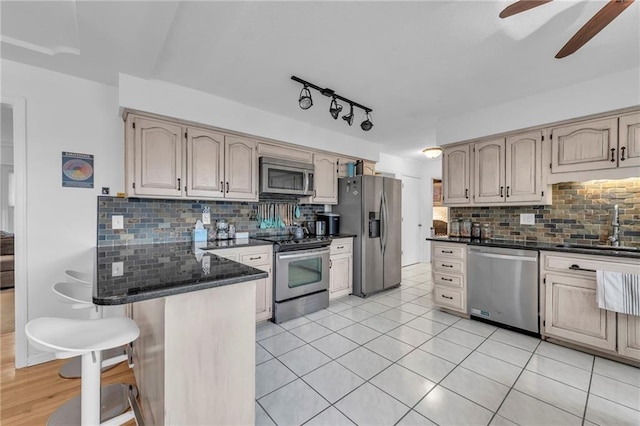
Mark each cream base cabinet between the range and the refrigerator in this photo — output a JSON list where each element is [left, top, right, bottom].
[[329, 238, 353, 299]]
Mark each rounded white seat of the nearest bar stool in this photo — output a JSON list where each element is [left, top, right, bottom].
[[25, 317, 140, 358]]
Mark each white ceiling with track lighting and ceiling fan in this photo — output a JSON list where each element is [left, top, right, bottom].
[[0, 0, 640, 156]]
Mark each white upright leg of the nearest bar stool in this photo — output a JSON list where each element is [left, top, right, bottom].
[[80, 351, 102, 426]]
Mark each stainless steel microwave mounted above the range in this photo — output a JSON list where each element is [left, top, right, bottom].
[[260, 157, 314, 196]]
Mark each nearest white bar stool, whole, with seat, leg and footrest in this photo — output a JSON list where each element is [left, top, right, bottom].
[[25, 317, 140, 426]]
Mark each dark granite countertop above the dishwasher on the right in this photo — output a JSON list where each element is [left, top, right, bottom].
[[427, 237, 640, 259]]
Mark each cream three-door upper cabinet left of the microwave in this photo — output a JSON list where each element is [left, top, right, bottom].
[[125, 114, 258, 200]]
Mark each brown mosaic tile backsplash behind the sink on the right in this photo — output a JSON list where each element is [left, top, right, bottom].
[[449, 178, 640, 246]]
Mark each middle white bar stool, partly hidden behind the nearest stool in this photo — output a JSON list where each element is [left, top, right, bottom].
[[51, 282, 127, 379]]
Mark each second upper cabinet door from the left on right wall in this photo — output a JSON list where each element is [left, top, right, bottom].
[[473, 139, 505, 203]]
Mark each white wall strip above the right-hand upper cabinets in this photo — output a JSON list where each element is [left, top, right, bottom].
[[437, 68, 640, 145]]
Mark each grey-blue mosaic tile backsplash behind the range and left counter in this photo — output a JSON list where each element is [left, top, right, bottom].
[[97, 197, 324, 246]]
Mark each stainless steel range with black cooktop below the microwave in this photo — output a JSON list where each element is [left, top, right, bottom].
[[260, 235, 331, 323]]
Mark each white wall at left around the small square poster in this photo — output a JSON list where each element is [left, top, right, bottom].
[[2, 60, 124, 364]]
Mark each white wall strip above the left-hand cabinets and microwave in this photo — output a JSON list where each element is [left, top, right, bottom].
[[119, 74, 381, 161]]
